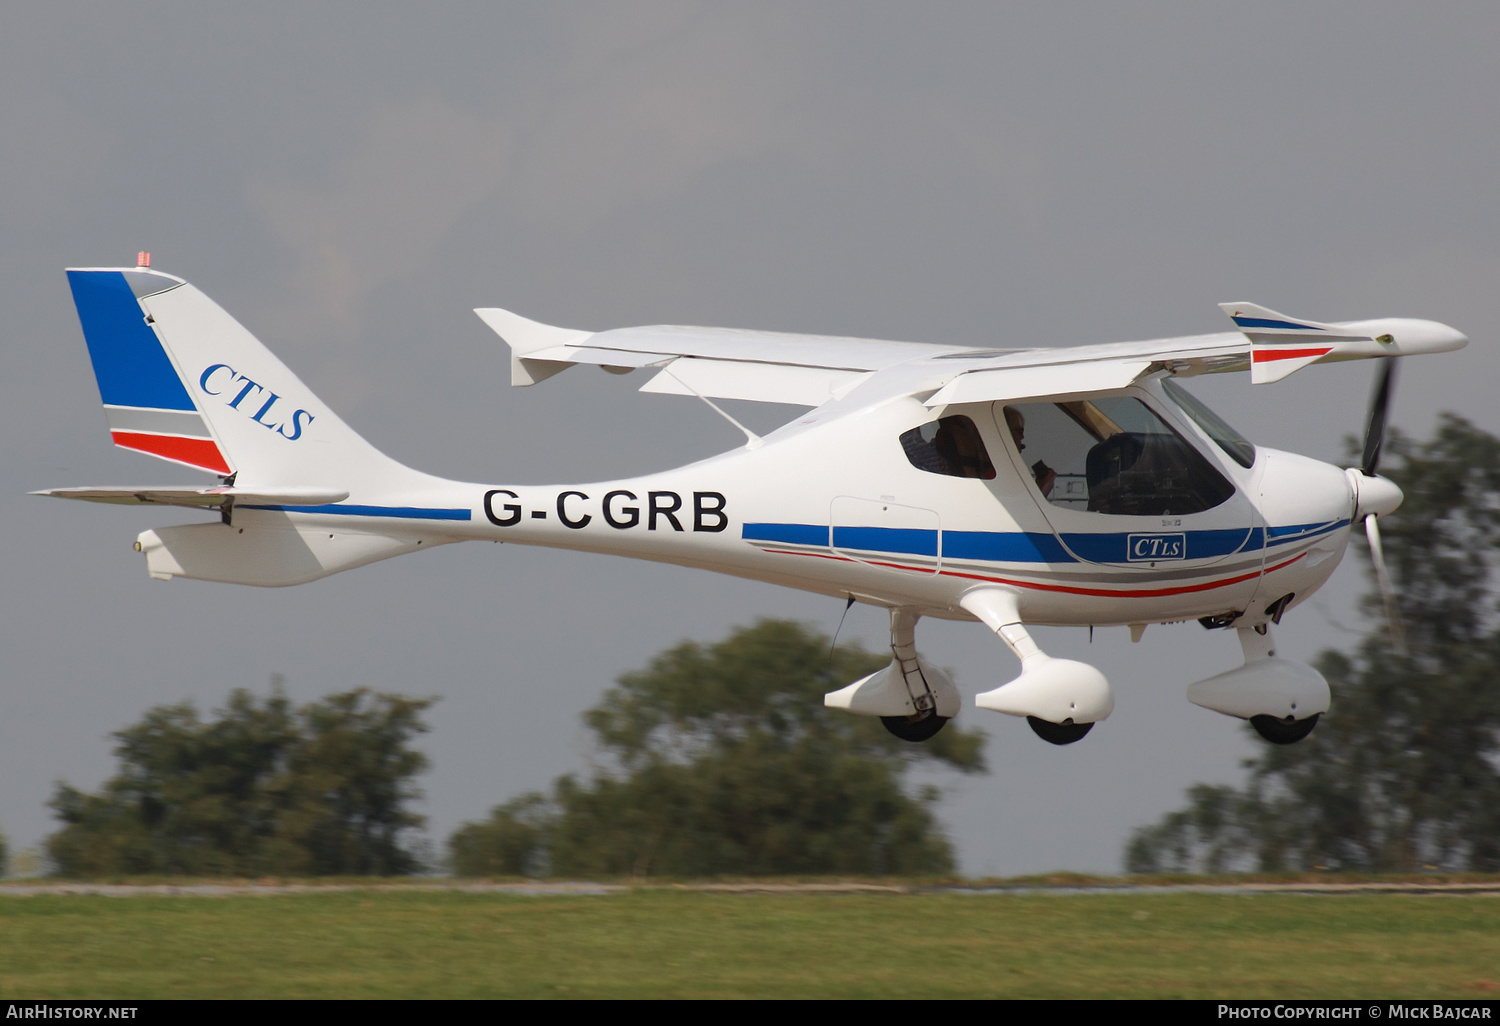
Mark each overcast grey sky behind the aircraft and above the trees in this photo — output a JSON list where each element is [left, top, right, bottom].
[[0, 0, 1500, 873]]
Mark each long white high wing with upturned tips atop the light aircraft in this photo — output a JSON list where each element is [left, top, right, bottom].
[[476, 303, 1469, 407]]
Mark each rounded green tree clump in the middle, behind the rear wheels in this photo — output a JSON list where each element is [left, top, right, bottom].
[[449, 620, 984, 876]]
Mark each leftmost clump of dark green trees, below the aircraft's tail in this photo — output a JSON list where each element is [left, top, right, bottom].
[[47, 689, 432, 878]]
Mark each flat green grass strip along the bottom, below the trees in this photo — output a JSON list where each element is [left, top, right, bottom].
[[0, 890, 1500, 999]]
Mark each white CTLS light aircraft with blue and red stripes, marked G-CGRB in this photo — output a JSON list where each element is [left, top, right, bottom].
[[38, 262, 1467, 744]]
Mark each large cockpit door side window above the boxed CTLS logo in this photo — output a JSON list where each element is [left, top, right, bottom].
[[1005, 396, 1235, 516]]
